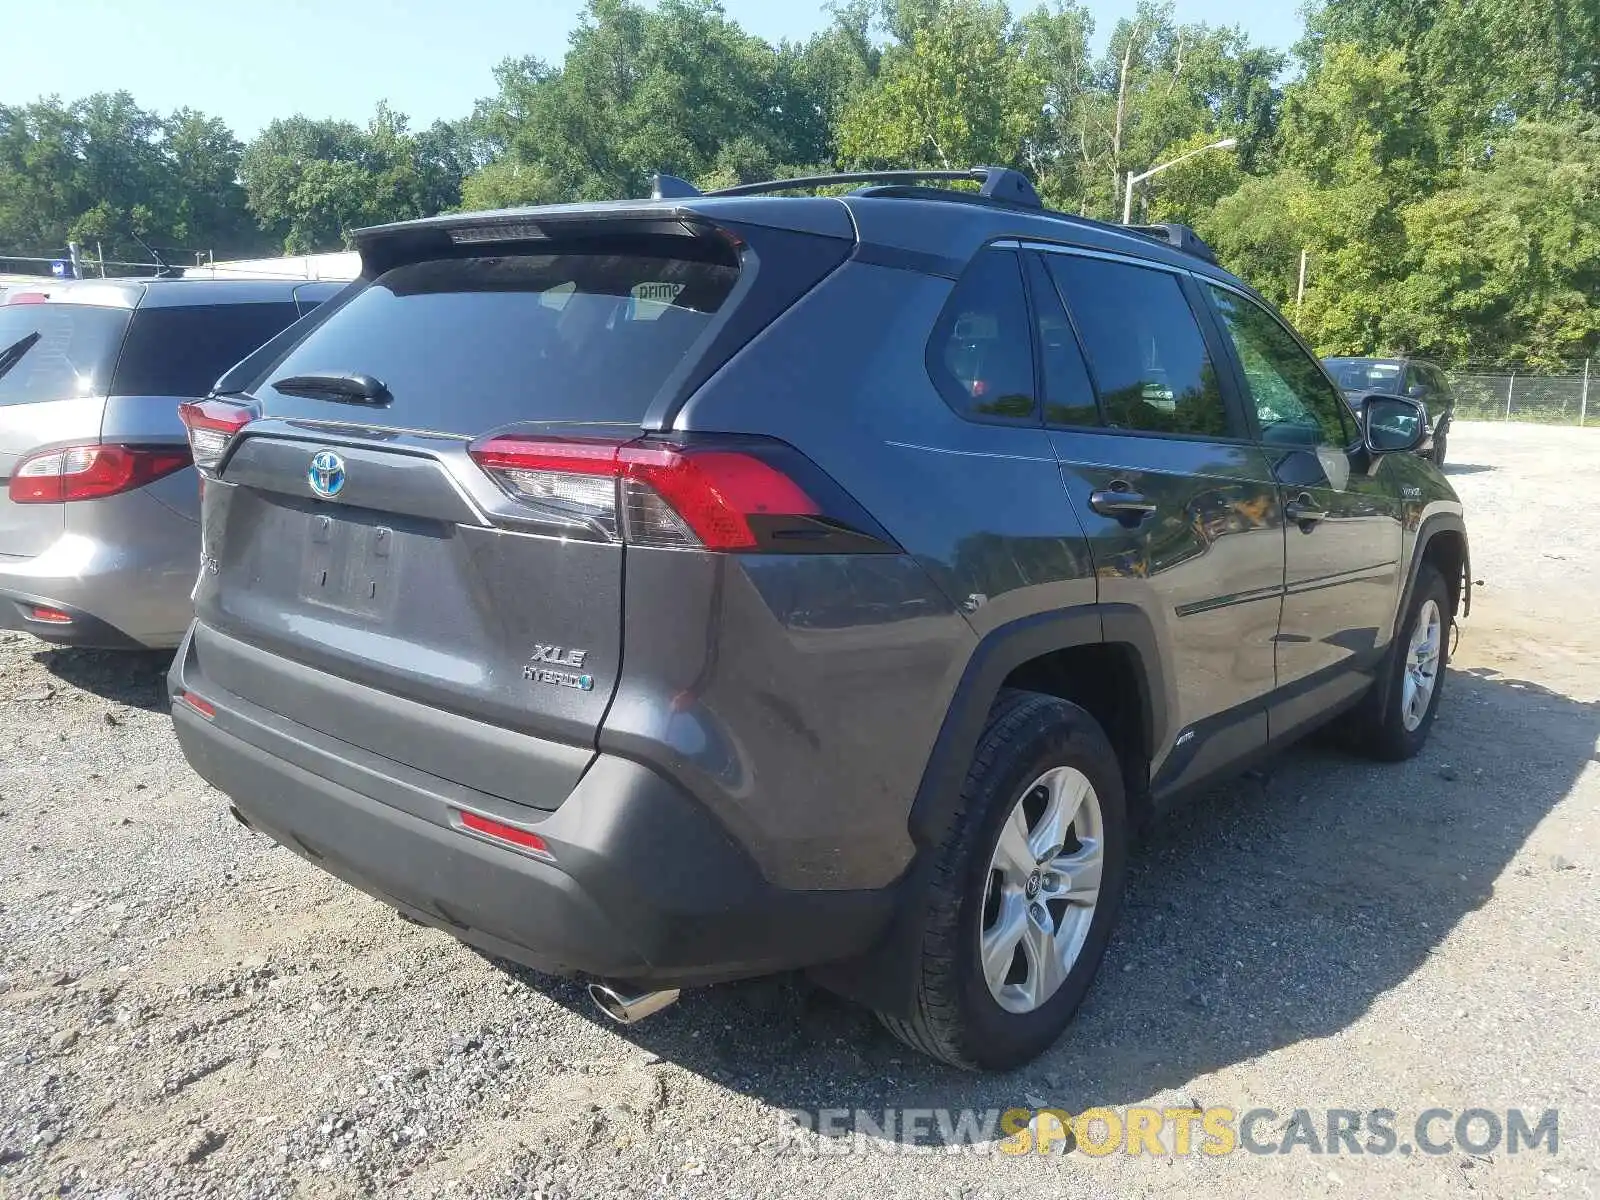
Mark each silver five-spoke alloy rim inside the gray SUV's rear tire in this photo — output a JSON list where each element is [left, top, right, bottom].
[[979, 766, 1106, 1013]]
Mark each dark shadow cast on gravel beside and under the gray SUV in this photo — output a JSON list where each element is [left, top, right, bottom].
[[505, 670, 1600, 1141]]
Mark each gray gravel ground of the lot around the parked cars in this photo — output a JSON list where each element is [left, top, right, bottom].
[[0, 424, 1600, 1200]]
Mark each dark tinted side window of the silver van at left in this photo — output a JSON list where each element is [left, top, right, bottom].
[[114, 301, 299, 395]]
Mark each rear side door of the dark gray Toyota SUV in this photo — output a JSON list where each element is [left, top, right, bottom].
[[1034, 251, 1283, 792]]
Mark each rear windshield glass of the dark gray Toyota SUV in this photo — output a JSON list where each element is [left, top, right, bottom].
[[251, 253, 739, 430]]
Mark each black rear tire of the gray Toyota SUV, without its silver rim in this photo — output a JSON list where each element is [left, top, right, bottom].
[[878, 691, 1130, 1070]]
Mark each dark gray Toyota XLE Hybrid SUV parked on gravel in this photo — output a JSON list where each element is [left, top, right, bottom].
[[171, 168, 1469, 1069]]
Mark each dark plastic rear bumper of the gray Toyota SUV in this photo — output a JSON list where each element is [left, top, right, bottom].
[[170, 630, 893, 987]]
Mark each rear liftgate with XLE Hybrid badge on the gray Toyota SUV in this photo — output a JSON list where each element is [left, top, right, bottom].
[[195, 232, 843, 803]]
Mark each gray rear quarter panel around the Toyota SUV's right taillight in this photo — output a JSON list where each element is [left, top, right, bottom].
[[659, 262, 1096, 888]]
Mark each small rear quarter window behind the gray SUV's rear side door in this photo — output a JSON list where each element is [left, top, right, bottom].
[[928, 250, 1035, 422]]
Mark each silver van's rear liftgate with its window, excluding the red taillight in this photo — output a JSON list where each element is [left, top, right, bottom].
[[0, 291, 128, 558]]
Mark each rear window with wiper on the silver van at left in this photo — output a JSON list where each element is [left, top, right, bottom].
[[0, 304, 128, 408]]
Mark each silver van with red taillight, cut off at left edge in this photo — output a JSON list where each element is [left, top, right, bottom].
[[0, 278, 338, 648]]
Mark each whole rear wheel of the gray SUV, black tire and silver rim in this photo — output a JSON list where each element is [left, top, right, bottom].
[[878, 690, 1130, 1070]]
